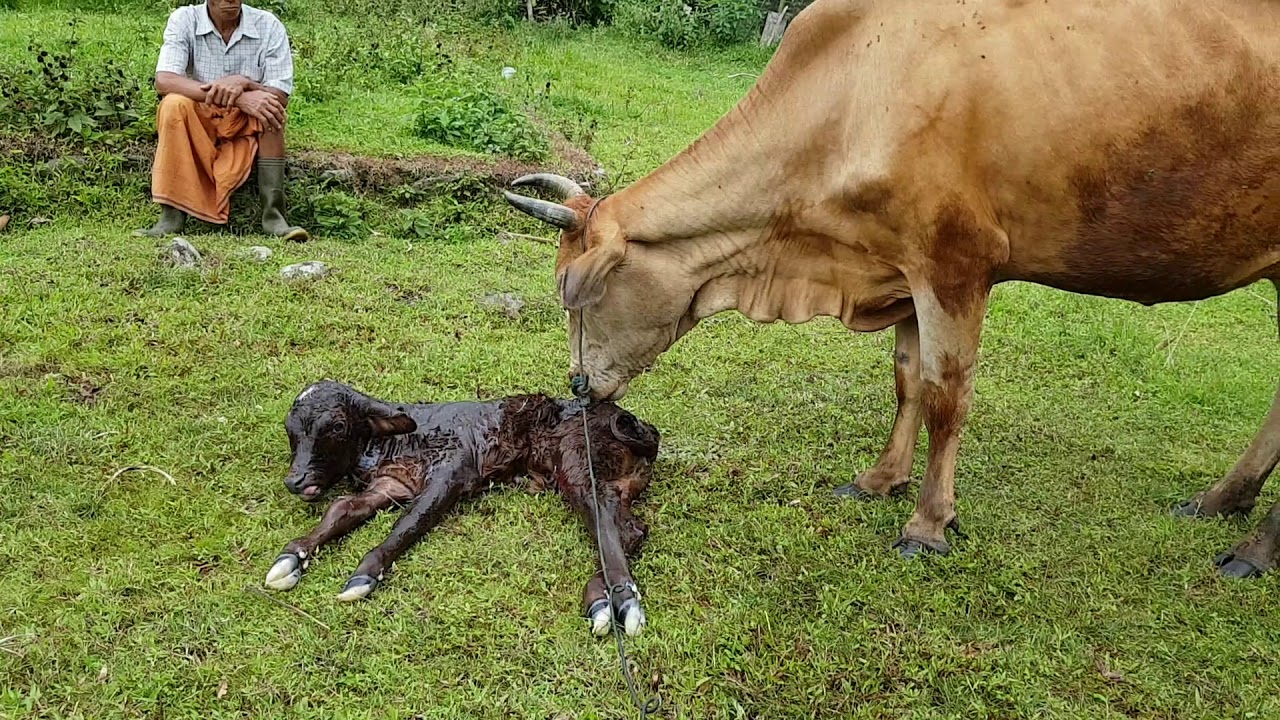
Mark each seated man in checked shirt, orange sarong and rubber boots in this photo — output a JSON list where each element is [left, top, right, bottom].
[[134, 0, 307, 241]]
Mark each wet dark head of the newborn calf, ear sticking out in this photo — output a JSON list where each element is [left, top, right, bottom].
[[284, 380, 417, 502]]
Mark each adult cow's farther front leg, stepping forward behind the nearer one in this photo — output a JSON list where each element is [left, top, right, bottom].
[[836, 315, 923, 500]]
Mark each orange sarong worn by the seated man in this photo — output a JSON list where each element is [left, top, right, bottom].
[[151, 94, 262, 224]]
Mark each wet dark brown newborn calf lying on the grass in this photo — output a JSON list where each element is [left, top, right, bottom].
[[266, 380, 659, 635]]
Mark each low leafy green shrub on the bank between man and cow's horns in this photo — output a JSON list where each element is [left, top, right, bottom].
[[413, 76, 549, 161]]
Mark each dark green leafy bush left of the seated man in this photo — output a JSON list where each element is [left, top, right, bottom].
[[0, 20, 147, 142]]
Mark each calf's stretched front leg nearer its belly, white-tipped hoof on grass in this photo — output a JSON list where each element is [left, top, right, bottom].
[[338, 461, 479, 602]]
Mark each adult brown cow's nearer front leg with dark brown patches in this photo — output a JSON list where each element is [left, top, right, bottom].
[[893, 283, 989, 557]]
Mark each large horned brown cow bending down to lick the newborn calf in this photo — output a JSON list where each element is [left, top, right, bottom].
[[507, 0, 1280, 575]]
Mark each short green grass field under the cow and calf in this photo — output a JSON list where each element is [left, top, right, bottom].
[[0, 2, 1280, 720]]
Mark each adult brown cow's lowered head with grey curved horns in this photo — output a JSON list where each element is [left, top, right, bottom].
[[506, 173, 696, 400]]
